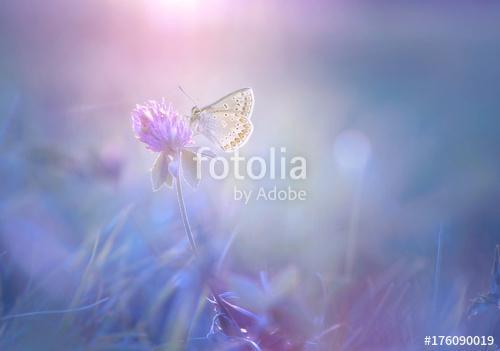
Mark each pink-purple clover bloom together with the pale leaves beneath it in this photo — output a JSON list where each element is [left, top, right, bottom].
[[132, 99, 208, 191]]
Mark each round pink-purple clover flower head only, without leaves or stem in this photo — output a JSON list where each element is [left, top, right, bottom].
[[132, 99, 193, 155]]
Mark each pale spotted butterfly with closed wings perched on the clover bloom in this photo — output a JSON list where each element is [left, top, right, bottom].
[[190, 88, 255, 152]]
